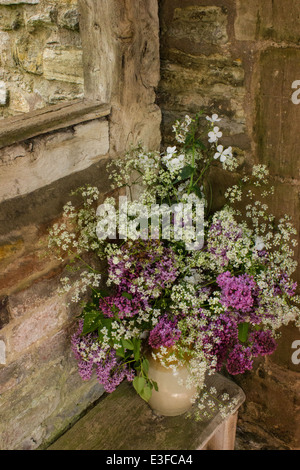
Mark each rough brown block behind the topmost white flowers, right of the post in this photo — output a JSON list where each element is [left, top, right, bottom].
[[158, 53, 245, 142]]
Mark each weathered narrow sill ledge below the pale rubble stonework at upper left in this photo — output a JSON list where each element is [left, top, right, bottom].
[[0, 99, 110, 148]]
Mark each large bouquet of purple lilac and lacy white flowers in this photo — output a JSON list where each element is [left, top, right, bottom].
[[49, 113, 300, 416]]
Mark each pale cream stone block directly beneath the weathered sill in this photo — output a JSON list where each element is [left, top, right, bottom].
[[0, 120, 109, 201]]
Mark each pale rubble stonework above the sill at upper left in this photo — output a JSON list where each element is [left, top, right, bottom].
[[0, 0, 84, 118]]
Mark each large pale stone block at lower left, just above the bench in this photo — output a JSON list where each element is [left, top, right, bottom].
[[0, 334, 103, 450]]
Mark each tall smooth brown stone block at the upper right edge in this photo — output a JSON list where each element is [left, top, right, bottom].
[[256, 48, 300, 179]]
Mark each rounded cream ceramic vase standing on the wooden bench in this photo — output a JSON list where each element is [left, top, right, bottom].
[[147, 346, 196, 416]]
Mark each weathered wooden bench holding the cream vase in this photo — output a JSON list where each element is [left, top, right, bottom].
[[48, 374, 245, 450]]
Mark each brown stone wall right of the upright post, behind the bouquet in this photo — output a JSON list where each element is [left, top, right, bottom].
[[158, 0, 300, 449]]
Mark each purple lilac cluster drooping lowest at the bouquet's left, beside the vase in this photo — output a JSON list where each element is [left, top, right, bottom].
[[71, 320, 134, 393]]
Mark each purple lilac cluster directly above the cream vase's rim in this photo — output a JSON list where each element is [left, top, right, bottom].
[[148, 315, 181, 349]]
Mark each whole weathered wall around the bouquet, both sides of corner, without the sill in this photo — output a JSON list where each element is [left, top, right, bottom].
[[0, 0, 300, 450]]
